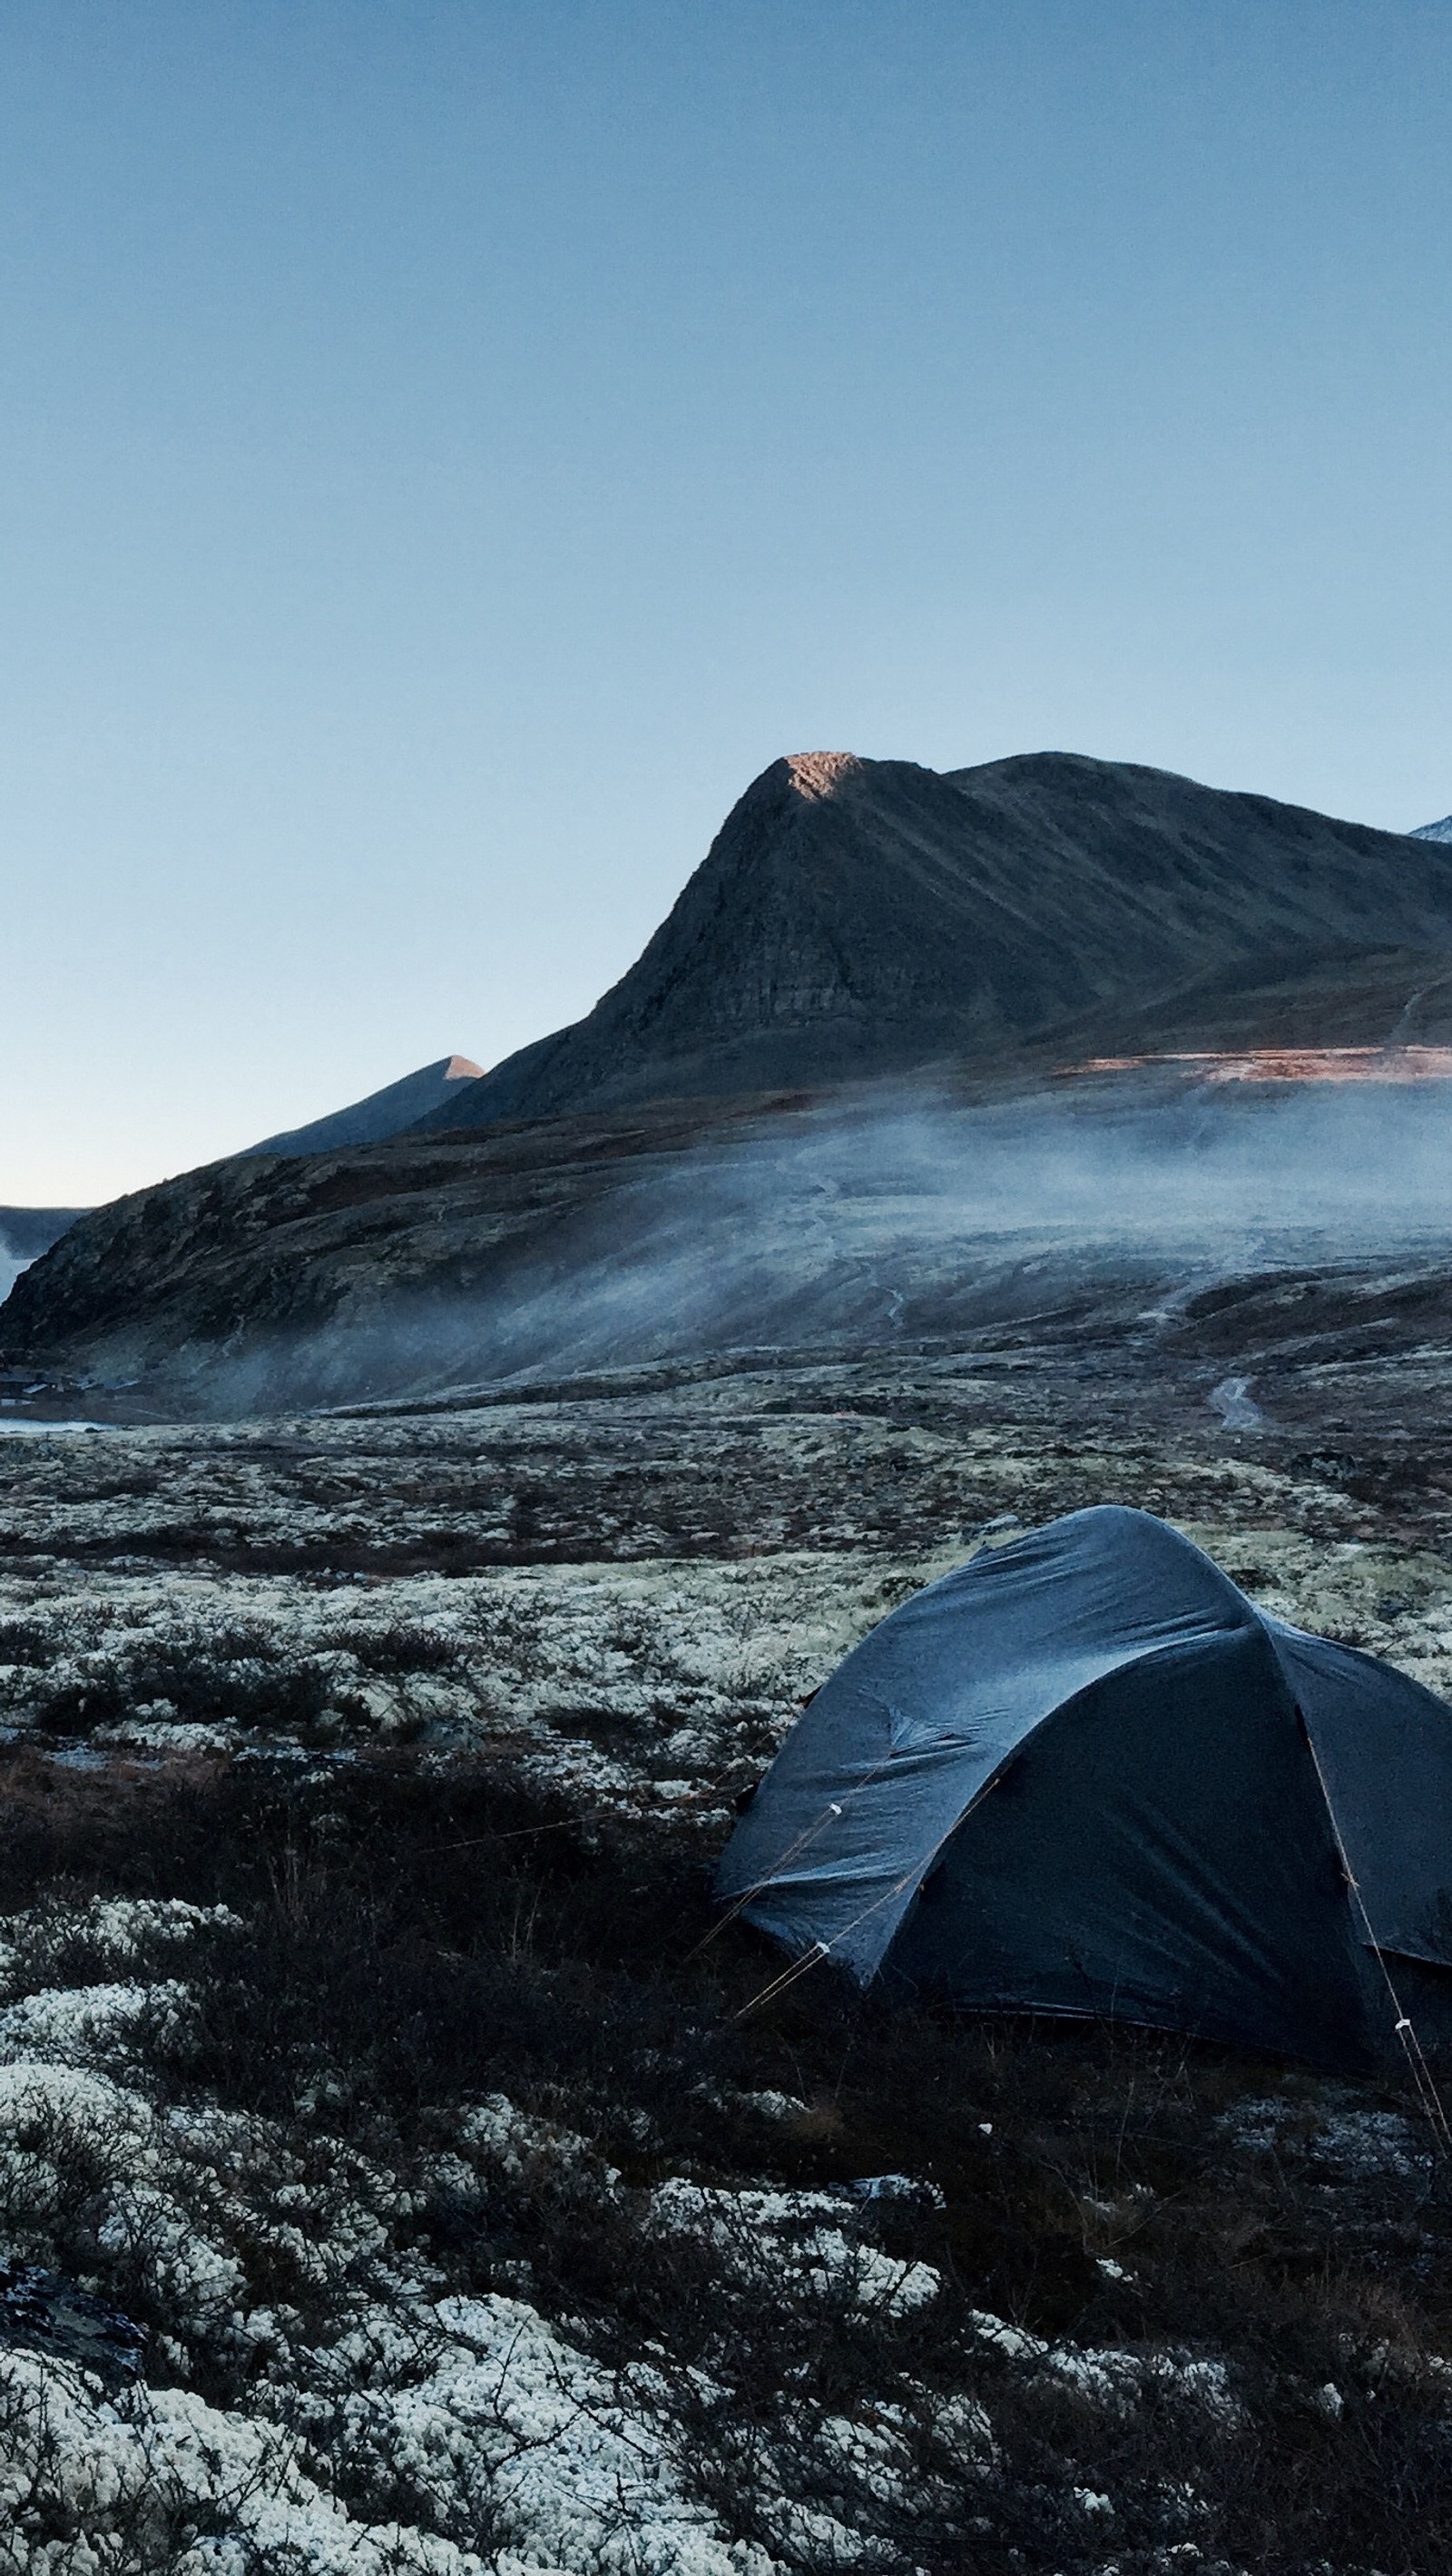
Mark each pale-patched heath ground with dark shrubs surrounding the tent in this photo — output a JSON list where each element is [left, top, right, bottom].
[[0, 1352, 1452, 2576]]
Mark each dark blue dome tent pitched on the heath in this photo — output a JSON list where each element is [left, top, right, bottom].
[[718, 1507, 1452, 2069]]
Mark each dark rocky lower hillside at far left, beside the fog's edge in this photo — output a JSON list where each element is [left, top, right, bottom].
[[0, 1110, 746, 1411]]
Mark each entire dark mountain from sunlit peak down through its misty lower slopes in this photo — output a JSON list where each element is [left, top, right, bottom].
[[16, 755, 1452, 1411]]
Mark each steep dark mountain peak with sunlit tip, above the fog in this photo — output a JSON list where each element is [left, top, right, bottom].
[[427, 752, 1452, 1126]]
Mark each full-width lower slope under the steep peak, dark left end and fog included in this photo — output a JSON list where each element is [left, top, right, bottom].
[[11, 1058, 1452, 1420]]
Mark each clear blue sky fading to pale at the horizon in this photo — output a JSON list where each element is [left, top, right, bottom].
[[0, 0, 1452, 1203]]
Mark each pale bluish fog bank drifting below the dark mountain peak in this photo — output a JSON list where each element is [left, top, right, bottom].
[[250, 1077, 1452, 1399]]
